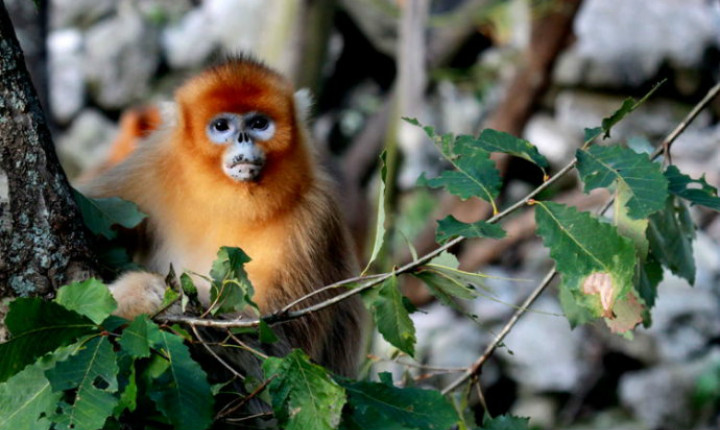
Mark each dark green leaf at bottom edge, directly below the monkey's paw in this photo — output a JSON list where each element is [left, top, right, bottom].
[[148, 331, 213, 430]]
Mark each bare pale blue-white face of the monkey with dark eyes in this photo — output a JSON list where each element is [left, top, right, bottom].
[[206, 112, 275, 181]]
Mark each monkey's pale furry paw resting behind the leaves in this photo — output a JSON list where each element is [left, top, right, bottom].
[[109, 272, 166, 320]]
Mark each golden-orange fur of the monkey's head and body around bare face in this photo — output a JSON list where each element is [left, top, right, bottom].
[[87, 58, 363, 374]]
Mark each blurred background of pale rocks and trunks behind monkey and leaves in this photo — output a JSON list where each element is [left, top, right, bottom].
[[5, 0, 720, 430]]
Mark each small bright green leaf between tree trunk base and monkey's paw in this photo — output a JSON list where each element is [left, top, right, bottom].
[[55, 278, 117, 324]]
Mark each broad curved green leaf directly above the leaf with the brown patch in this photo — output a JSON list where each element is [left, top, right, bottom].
[[576, 145, 668, 219]]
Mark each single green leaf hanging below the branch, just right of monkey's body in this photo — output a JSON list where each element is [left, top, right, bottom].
[[365, 275, 416, 356]]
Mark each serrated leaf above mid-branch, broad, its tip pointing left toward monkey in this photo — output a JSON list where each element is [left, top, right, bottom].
[[418, 150, 502, 204]]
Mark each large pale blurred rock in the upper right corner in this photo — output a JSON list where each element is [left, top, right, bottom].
[[555, 0, 720, 87]]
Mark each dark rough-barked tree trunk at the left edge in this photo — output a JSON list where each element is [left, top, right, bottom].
[[0, 2, 96, 298]]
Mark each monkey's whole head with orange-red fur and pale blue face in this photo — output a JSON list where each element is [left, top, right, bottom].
[[176, 57, 308, 183]]
